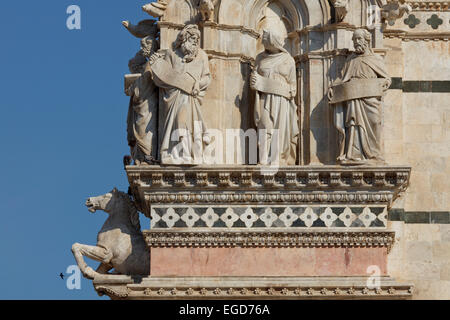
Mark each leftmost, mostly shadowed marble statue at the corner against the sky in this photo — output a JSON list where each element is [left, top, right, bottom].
[[125, 34, 159, 165]]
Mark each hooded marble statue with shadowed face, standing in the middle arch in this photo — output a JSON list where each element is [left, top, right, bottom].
[[250, 30, 299, 165]]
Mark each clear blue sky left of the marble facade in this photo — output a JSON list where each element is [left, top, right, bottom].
[[0, 0, 156, 299]]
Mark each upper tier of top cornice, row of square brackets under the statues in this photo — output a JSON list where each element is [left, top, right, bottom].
[[126, 166, 411, 191]]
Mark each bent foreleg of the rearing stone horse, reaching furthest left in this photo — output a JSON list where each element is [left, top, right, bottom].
[[72, 243, 112, 279]]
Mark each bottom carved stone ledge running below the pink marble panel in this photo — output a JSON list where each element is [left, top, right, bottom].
[[94, 276, 414, 300]]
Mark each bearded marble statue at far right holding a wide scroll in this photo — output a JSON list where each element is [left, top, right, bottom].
[[328, 29, 391, 164]]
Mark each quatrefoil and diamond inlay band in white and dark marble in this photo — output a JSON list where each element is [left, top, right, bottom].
[[151, 205, 387, 229]]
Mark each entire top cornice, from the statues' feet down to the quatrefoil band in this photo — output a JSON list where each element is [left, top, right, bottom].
[[126, 166, 410, 217]]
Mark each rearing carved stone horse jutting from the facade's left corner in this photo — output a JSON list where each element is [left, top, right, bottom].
[[72, 188, 150, 279]]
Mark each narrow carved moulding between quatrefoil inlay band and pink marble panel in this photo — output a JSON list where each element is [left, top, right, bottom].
[[143, 229, 395, 252]]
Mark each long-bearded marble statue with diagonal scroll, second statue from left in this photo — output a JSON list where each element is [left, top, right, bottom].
[[150, 24, 211, 164]]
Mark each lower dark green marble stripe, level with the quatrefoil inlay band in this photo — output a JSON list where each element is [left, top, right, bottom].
[[388, 209, 450, 224]]
